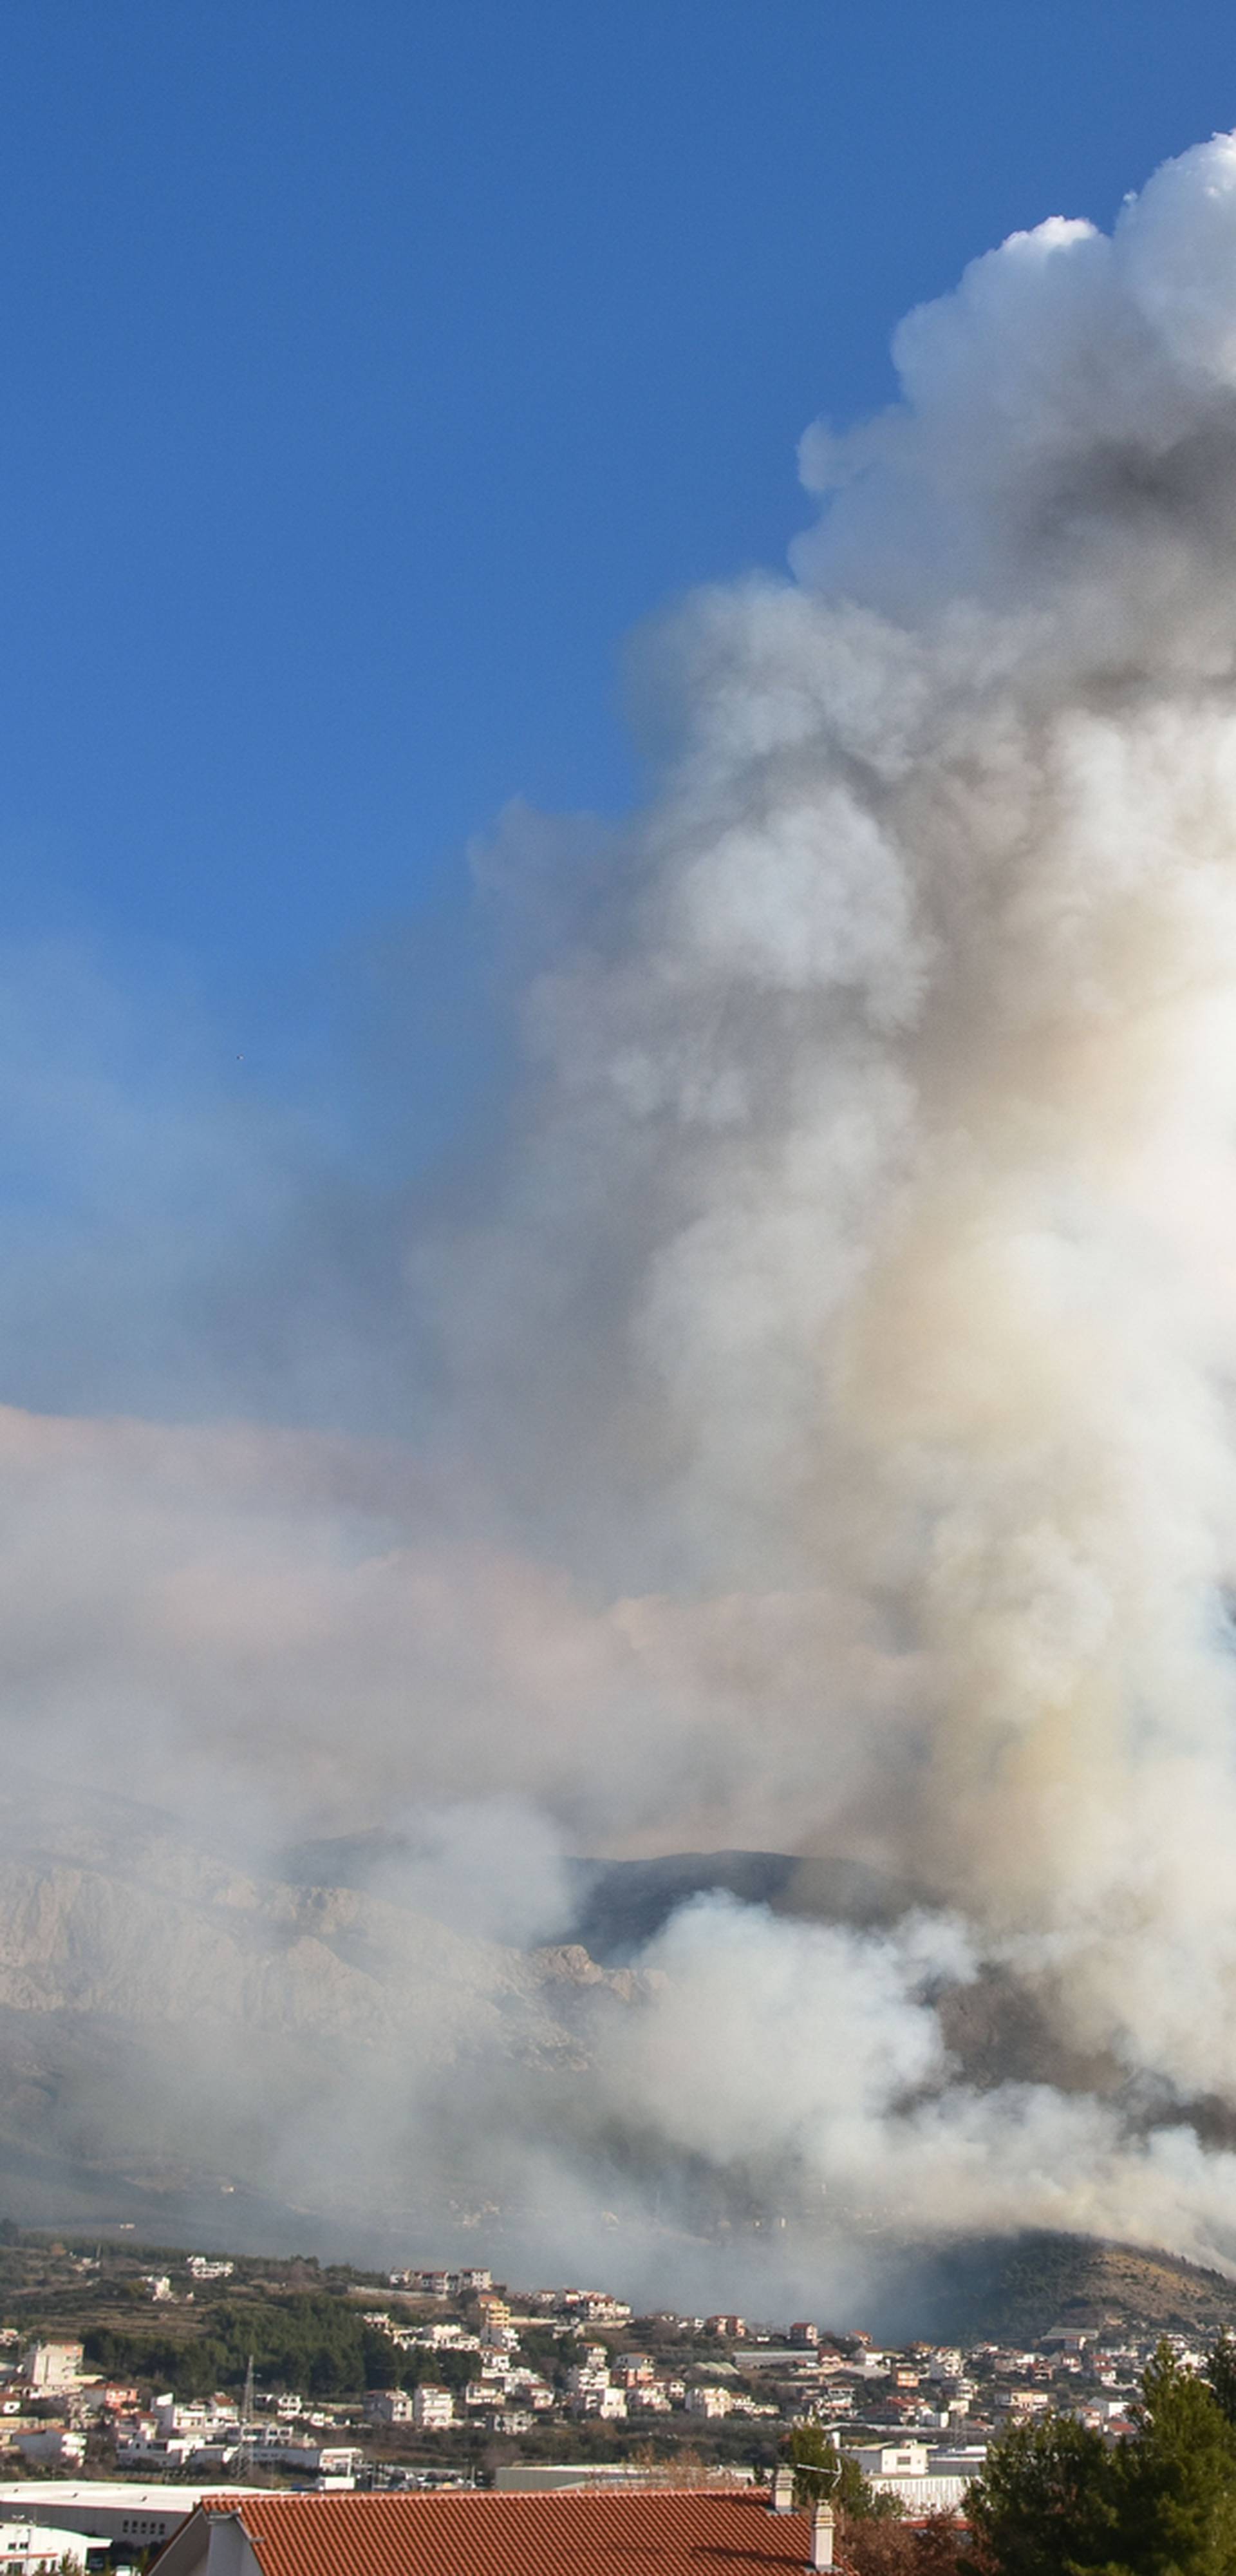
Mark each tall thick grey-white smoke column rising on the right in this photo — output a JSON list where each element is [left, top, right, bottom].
[[430, 137, 1236, 2251]]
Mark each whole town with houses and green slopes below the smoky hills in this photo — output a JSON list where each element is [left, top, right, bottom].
[[0, 2223, 1236, 2512]]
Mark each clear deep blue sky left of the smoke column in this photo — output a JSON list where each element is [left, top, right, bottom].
[[0, 0, 1236, 1401]]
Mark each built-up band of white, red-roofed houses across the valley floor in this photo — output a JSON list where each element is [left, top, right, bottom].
[[0, 2257, 1205, 2512]]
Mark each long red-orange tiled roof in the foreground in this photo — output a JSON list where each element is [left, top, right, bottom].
[[196, 2486, 811, 2576]]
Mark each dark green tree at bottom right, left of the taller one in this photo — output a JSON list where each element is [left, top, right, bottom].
[[966, 2414, 1120, 2576]]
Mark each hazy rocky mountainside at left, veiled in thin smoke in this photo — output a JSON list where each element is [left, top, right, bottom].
[[0, 1783, 641, 2246]]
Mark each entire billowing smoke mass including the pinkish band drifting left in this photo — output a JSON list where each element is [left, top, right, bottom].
[[12, 121, 1236, 2295]]
